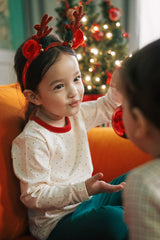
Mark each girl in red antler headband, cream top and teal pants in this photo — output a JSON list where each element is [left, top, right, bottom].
[[12, 7, 127, 240]]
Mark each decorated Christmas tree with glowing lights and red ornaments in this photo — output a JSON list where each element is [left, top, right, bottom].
[[56, 0, 128, 96]]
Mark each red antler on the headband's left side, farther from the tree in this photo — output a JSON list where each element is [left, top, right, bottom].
[[32, 14, 53, 42]]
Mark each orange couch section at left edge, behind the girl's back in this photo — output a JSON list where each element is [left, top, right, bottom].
[[0, 84, 28, 240]]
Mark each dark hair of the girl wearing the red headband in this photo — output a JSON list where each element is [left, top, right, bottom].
[[14, 34, 76, 122]]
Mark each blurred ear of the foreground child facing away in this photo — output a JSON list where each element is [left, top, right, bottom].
[[132, 107, 150, 139]]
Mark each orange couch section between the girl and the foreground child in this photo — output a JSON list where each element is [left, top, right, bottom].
[[88, 127, 151, 182]]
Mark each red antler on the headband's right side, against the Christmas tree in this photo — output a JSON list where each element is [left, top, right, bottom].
[[65, 6, 86, 33]]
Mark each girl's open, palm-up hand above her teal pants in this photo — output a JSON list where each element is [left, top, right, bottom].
[[85, 173, 126, 196]]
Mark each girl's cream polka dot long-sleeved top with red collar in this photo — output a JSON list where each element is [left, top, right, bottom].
[[12, 88, 120, 240]]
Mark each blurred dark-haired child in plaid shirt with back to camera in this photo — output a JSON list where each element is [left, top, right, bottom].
[[117, 39, 160, 240]]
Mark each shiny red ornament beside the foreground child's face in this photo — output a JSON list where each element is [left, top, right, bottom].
[[112, 106, 126, 138]]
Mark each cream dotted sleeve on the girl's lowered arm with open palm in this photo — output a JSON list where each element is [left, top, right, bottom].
[[12, 132, 89, 210]]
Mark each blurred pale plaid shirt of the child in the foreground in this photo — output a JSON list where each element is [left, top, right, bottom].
[[123, 160, 160, 240]]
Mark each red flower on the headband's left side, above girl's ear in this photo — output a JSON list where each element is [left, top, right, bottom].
[[22, 39, 41, 60]]
